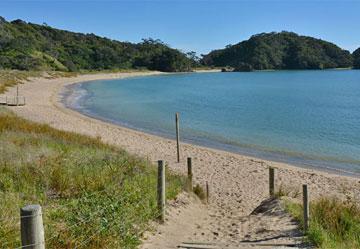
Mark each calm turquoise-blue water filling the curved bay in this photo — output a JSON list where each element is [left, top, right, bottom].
[[70, 70, 360, 174]]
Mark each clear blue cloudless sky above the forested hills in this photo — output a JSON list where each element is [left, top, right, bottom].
[[0, 0, 360, 55]]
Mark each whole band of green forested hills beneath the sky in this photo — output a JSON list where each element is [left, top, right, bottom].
[[0, 17, 360, 72]]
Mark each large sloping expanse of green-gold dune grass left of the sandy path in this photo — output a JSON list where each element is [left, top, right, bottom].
[[0, 107, 185, 249]]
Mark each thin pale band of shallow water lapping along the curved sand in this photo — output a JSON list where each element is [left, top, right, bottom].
[[63, 71, 360, 178]]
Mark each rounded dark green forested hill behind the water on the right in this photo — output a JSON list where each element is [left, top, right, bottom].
[[202, 32, 353, 71]]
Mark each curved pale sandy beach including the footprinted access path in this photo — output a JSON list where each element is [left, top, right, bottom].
[[1, 72, 360, 248]]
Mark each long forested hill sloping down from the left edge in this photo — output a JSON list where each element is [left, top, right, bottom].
[[0, 17, 194, 72]]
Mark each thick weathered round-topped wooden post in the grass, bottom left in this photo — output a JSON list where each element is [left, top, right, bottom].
[[20, 205, 45, 249]]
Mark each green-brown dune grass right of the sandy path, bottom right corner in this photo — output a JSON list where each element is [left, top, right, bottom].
[[285, 198, 360, 249]]
